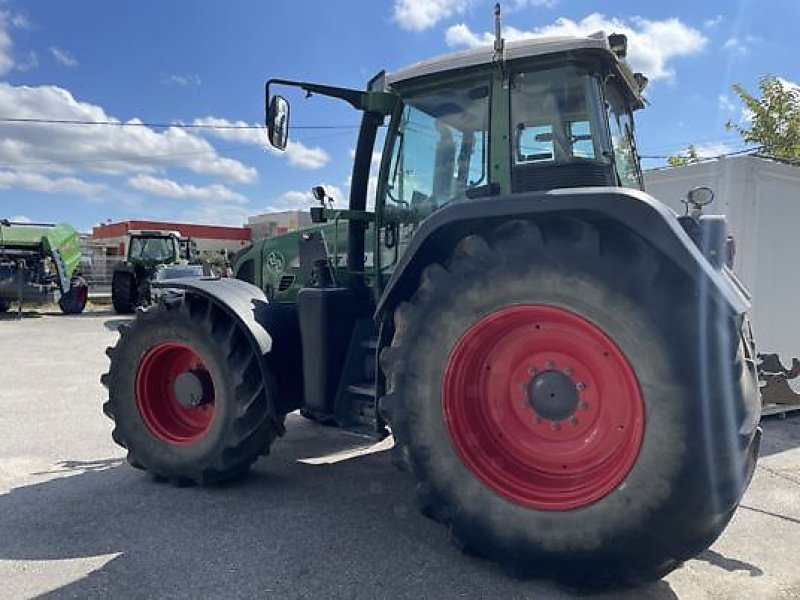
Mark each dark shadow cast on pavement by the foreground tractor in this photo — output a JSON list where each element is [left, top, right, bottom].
[[0, 417, 677, 600]]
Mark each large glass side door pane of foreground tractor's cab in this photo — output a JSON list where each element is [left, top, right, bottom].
[[386, 77, 490, 216]]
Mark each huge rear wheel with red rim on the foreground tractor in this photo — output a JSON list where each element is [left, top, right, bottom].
[[381, 219, 747, 587]]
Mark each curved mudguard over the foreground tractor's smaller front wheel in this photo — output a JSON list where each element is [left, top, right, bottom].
[[152, 277, 303, 414]]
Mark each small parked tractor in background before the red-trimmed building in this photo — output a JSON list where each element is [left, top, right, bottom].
[[111, 231, 207, 314]]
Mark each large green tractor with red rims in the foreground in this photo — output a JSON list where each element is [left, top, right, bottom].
[[102, 24, 760, 585]]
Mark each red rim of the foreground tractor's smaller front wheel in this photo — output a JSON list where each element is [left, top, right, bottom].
[[136, 342, 214, 446]]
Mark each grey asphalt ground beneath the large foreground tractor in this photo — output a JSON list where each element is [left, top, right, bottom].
[[0, 312, 800, 600]]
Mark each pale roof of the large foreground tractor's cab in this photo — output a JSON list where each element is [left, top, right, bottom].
[[385, 31, 646, 104]]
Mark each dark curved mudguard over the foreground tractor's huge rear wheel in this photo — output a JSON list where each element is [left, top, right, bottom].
[[375, 187, 750, 321]]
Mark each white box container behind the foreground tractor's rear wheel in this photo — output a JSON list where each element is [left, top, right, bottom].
[[645, 156, 800, 412]]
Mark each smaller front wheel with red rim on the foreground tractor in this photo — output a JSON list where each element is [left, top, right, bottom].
[[101, 295, 282, 484]]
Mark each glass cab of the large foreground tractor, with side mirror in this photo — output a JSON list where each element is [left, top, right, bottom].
[[266, 33, 647, 301]]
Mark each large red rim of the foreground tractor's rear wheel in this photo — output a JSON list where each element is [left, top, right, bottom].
[[442, 305, 644, 510]]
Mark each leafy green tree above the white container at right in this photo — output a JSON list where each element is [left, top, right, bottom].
[[726, 75, 800, 159]]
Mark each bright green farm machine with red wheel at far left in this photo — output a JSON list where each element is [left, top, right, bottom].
[[0, 219, 89, 314]]
